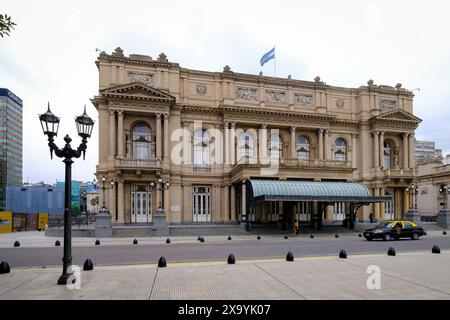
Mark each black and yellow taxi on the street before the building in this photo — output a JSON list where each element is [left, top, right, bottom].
[[363, 220, 427, 241]]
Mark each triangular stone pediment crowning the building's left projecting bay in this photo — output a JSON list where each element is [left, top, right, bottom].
[[100, 82, 175, 103]]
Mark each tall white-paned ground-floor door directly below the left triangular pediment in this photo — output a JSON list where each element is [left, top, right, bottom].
[[131, 185, 152, 223]]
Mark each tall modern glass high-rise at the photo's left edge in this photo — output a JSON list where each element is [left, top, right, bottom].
[[0, 88, 23, 211]]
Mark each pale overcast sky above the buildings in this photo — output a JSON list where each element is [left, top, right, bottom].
[[0, 0, 450, 183]]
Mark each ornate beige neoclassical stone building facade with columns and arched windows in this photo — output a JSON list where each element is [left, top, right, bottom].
[[91, 48, 421, 224]]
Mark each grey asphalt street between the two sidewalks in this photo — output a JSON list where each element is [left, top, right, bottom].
[[0, 236, 450, 268]]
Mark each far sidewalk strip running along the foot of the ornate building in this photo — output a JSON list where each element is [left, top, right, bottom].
[[0, 230, 442, 248]]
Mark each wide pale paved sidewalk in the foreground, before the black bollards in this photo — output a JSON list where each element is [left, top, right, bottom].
[[0, 251, 450, 300]]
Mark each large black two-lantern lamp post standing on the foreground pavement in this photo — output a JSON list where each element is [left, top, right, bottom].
[[39, 103, 94, 285]]
